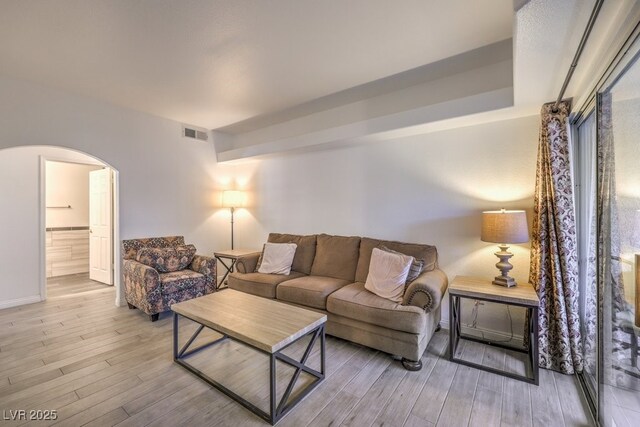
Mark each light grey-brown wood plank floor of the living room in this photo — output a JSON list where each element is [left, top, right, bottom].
[[0, 279, 593, 427]]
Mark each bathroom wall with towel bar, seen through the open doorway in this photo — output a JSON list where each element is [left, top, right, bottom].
[[46, 161, 100, 228]]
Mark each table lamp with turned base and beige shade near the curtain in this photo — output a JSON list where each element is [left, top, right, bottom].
[[480, 209, 529, 288]]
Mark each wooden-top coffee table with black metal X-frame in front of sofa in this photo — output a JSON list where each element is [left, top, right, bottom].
[[171, 289, 327, 424]]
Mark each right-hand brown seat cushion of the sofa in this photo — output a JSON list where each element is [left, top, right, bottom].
[[327, 282, 426, 334]]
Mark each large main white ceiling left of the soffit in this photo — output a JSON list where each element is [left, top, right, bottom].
[[0, 0, 512, 129]]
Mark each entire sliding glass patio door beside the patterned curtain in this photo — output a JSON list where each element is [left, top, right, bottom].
[[573, 25, 640, 427]]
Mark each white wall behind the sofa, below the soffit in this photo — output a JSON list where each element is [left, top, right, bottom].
[[235, 116, 539, 342]]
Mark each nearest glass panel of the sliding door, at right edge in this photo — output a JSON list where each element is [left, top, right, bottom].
[[597, 49, 640, 426]]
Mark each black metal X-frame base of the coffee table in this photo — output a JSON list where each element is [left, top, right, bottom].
[[173, 313, 325, 425]]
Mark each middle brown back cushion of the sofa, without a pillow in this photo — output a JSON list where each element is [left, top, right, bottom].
[[311, 234, 366, 281]]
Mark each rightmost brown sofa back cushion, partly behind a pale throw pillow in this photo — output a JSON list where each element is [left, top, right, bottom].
[[355, 237, 438, 283]]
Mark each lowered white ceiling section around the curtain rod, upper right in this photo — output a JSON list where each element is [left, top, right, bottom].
[[514, 0, 640, 113]]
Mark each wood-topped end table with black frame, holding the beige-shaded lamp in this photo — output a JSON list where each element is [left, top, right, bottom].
[[448, 276, 540, 385]]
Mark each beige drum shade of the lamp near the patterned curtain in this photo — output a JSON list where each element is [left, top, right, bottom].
[[480, 209, 529, 243]]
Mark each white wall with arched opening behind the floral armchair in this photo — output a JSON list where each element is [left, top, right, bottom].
[[0, 77, 229, 307]]
